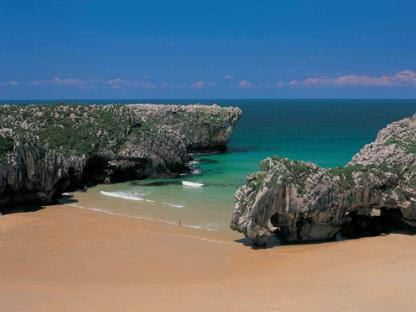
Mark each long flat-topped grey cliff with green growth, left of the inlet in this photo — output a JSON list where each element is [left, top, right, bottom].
[[0, 104, 241, 207]]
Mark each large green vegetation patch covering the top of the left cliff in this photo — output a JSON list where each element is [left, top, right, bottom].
[[0, 104, 135, 156]]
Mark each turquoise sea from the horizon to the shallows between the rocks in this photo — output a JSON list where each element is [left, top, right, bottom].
[[3, 100, 416, 230]]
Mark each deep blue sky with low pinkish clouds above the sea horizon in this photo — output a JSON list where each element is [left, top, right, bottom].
[[0, 0, 416, 99]]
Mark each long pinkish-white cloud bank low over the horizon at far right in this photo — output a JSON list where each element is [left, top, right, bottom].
[[284, 70, 416, 87]]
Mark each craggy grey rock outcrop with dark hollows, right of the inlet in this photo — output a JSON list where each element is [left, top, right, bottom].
[[231, 115, 416, 246]]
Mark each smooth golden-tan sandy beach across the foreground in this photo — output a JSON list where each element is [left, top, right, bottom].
[[0, 201, 416, 312]]
